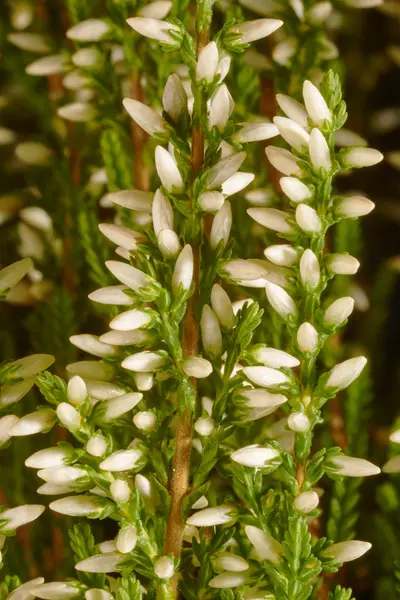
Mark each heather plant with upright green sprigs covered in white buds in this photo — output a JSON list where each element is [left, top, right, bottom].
[[0, 0, 398, 600]]
